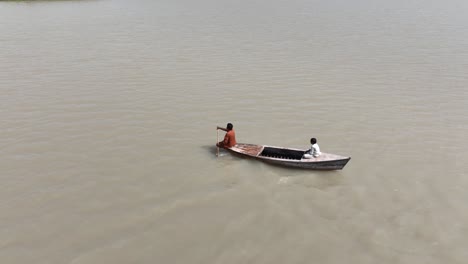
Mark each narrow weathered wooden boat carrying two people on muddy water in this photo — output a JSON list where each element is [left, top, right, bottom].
[[227, 143, 351, 170]]
